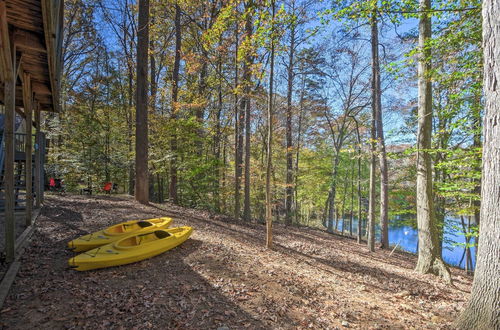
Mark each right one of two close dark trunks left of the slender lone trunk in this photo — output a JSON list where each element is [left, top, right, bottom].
[[243, 1, 253, 221]]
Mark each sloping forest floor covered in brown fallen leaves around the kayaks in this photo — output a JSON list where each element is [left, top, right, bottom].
[[0, 195, 471, 329]]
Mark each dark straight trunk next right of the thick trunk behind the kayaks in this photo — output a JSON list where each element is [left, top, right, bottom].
[[169, 2, 182, 204]]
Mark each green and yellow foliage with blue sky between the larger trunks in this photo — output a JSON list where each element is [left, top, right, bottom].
[[45, 0, 483, 266]]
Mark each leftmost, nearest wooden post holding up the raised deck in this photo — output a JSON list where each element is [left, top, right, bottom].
[[0, 1, 16, 262]]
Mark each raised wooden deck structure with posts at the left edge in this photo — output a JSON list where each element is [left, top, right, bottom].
[[0, 0, 64, 262]]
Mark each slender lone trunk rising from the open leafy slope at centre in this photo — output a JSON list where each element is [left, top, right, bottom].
[[266, 1, 275, 249]]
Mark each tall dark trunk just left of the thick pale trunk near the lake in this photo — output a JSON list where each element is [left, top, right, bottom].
[[371, 6, 389, 249]]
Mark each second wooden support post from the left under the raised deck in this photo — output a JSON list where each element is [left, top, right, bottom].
[[23, 73, 33, 226]]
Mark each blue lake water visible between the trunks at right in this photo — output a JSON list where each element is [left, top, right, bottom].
[[326, 217, 476, 269]]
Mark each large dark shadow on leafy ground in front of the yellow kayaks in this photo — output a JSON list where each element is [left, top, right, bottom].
[[0, 229, 266, 329]]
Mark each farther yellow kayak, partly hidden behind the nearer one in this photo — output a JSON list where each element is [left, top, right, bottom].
[[68, 217, 172, 252]]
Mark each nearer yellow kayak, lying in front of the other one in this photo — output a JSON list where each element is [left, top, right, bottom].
[[68, 226, 193, 271]]
